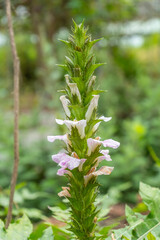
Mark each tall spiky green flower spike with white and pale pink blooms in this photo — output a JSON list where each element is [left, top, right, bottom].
[[48, 21, 120, 240]]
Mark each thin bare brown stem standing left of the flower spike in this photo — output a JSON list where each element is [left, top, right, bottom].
[[5, 0, 20, 228]]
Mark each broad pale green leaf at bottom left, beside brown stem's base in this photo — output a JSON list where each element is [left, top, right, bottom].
[[5, 215, 33, 240]]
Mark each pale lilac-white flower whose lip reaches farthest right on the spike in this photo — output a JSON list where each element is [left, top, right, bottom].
[[87, 138, 120, 156]]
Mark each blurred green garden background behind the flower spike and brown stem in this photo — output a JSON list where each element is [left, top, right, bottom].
[[0, 0, 160, 221]]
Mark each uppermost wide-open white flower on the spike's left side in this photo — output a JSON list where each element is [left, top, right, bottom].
[[56, 119, 86, 139]]
